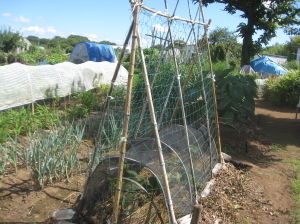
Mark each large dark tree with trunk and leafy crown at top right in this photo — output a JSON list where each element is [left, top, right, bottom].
[[192, 0, 300, 66]]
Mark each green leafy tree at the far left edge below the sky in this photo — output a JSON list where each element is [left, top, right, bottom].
[[0, 27, 25, 53]]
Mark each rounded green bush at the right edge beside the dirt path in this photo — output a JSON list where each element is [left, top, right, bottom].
[[263, 70, 300, 107]]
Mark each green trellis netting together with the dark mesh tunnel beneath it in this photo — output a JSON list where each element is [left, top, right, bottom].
[[79, 0, 219, 223]]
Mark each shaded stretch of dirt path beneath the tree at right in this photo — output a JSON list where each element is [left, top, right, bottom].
[[220, 99, 300, 168]]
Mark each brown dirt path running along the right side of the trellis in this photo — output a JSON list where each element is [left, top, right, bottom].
[[236, 99, 300, 224]]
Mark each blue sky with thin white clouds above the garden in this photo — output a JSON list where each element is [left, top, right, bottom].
[[0, 0, 290, 45]]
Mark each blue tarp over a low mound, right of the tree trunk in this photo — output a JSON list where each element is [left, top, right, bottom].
[[250, 56, 287, 77]]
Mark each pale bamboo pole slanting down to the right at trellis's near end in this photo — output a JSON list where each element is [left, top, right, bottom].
[[137, 28, 177, 223]]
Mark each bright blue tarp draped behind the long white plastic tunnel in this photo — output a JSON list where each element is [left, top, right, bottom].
[[84, 42, 116, 63]]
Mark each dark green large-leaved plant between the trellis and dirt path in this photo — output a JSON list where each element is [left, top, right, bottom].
[[214, 62, 257, 123]]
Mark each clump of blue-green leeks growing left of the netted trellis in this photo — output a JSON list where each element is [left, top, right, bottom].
[[28, 121, 84, 188]]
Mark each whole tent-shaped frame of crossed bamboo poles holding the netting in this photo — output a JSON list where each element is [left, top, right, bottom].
[[84, 0, 220, 223]]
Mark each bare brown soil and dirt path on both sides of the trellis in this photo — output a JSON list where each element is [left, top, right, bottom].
[[0, 99, 300, 224]]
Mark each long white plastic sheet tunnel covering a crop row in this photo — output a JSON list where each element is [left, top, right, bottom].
[[0, 61, 128, 110]]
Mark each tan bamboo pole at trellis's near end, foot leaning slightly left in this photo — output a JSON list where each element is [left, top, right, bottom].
[[112, 0, 142, 223]]
